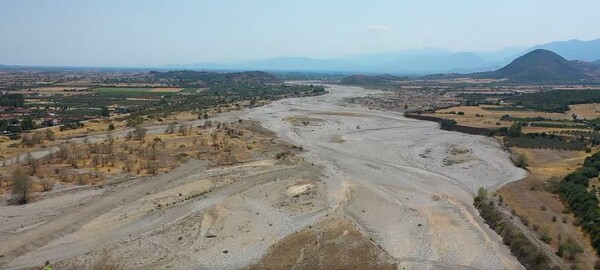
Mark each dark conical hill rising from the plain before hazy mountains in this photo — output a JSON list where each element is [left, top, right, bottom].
[[473, 49, 587, 82]]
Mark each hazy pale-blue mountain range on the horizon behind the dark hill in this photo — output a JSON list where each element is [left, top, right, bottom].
[[165, 39, 600, 75]]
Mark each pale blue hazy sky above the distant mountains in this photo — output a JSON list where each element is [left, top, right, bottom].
[[0, 0, 600, 67]]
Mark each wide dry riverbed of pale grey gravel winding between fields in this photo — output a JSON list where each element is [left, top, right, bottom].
[[0, 86, 525, 269]]
